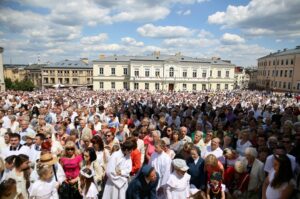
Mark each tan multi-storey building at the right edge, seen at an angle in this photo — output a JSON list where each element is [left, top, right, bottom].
[[257, 46, 300, 92]]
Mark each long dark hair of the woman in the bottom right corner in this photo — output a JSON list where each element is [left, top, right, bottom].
[[271, 155, 293, 188]]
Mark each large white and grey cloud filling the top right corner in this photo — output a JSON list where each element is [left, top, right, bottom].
[[208, 0, 300, 38]]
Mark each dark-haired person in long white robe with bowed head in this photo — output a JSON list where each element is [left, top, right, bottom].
[[102, 141, 133, 199]]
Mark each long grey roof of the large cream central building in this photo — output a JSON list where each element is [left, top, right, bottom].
[[93, 54, 233, 65]]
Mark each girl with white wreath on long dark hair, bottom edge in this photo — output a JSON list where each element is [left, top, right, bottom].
[[80, 168, 99, 199]]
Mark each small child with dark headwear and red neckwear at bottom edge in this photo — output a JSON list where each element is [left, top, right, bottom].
[[206, 172, 225, 199]]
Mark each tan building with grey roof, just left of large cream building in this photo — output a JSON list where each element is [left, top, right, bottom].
[[41, 58, 93, 88]]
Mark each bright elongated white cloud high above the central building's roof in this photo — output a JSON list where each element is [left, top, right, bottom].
[[137, 24, 194, 38]]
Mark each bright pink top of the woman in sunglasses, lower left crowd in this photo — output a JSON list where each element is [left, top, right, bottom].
[[60, 155, 82, 179]]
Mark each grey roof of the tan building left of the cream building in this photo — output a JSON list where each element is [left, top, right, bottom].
[[44, 59, 93, 69]]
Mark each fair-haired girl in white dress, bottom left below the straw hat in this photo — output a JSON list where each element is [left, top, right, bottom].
[[28, 163, 59, 199]]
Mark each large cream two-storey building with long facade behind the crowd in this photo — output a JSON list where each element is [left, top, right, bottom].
[[93, 52, 235, 91]]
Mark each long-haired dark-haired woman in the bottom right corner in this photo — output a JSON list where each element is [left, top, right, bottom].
[[262, 155, 295, 199]]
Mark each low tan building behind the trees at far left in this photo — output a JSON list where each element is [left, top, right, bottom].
[[4, 64, 28, 81]]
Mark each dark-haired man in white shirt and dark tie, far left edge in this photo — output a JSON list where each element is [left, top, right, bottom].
[[1, 133, 30, 159]]
